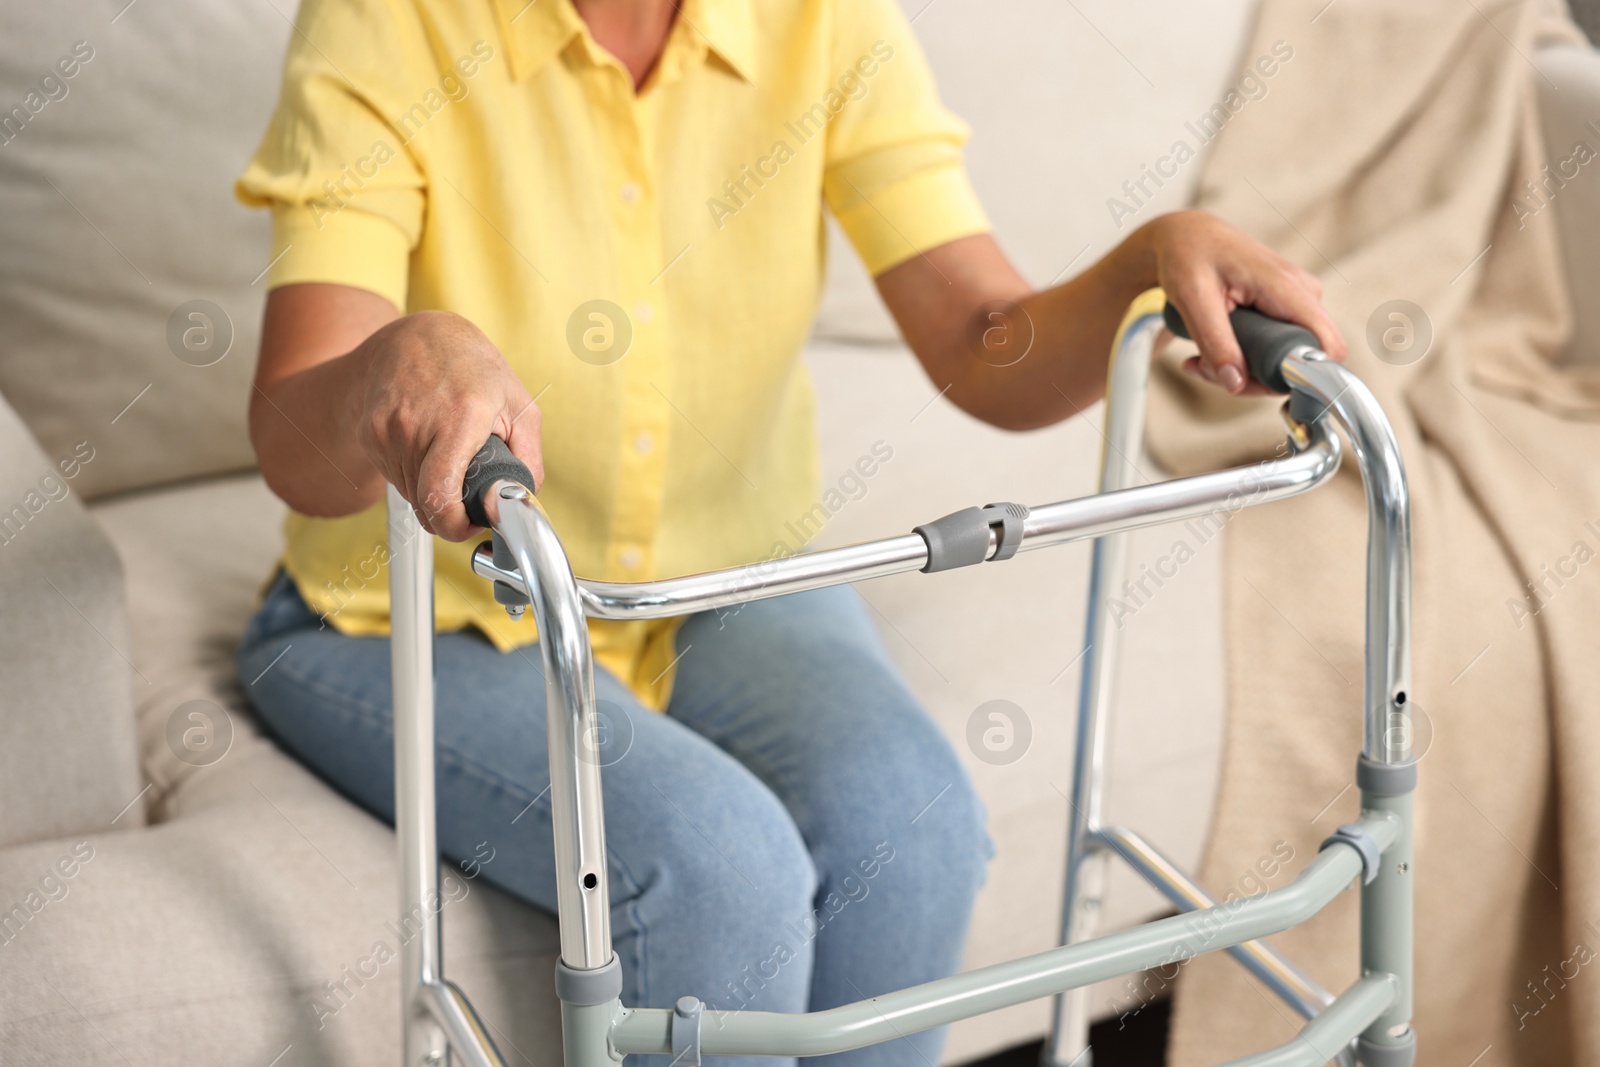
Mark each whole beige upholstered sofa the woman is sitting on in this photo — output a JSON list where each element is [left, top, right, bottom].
[[0, 0, 1587, 1067]]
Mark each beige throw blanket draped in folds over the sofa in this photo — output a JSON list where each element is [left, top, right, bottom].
[[1149, 0, 1600, 1067]]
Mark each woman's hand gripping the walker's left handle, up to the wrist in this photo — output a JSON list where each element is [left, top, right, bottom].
[[355, 312, 544, 541]]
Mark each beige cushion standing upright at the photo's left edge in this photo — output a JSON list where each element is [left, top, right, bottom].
[[0, 388, 147, 844]]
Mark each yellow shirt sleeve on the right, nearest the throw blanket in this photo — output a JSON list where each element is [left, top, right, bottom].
[[822, 0, 989, 275]]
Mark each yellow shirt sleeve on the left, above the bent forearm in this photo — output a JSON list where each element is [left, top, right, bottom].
[[235, 0, 426, 310]]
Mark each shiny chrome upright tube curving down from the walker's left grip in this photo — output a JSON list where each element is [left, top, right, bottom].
[[491, 482, 611, 971]]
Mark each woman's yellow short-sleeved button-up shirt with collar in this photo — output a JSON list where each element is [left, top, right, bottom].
[[237, 0, 987, 709]]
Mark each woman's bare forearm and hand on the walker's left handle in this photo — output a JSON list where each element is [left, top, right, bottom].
[[250, 282, 544, 541]]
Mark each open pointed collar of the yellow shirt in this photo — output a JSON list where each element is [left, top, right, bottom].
[[494, 0, 755, 82]]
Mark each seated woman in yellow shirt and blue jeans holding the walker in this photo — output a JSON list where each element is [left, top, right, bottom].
[[238, 0, 1341, 1065]]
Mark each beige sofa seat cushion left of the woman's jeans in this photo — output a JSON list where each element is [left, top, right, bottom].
[[43, 474, 560, 1067]]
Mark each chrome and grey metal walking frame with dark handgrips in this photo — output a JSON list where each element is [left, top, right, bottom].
[[389, 290, 1416, 1067]]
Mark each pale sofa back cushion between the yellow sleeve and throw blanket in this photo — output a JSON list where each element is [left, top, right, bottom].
[[816, 0, 1260, 341]]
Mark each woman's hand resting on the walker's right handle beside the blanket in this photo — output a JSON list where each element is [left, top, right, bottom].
[[1144, 211, 1346, 395]]
